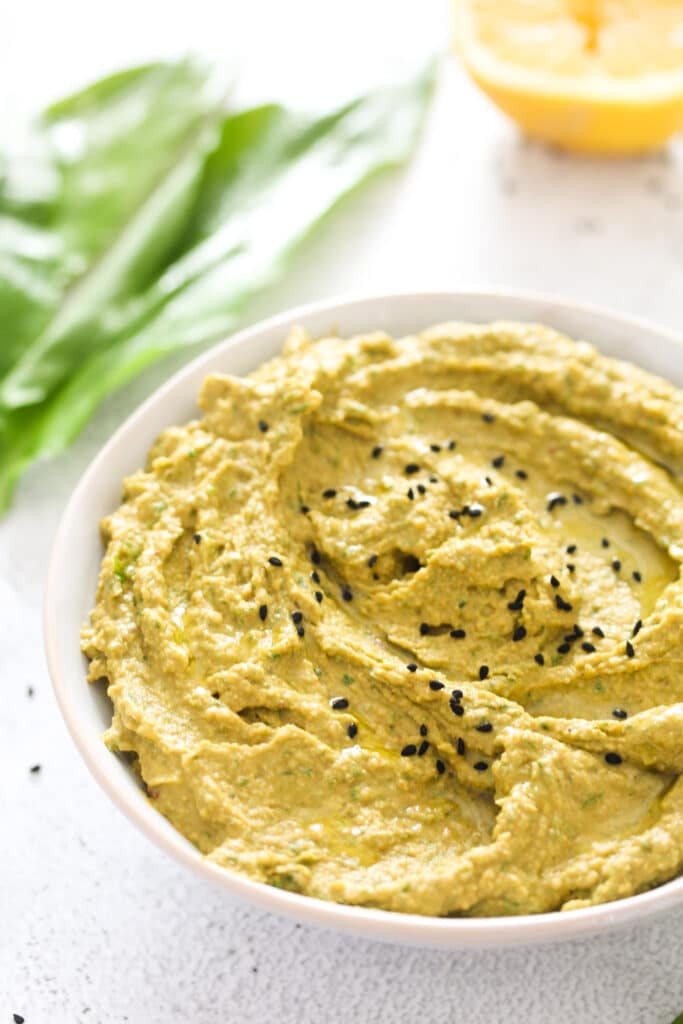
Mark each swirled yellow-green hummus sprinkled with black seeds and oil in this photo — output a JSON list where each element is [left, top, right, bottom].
[[83, 323, 683, 915]]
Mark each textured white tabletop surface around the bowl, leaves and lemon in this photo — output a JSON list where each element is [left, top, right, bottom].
[[0, 0, 683, 1024]]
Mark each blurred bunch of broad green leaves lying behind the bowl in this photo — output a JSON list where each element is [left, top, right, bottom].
[[0, 61, 434, 508]]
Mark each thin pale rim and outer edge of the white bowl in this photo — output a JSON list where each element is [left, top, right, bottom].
[[42, 287, 683, 949]]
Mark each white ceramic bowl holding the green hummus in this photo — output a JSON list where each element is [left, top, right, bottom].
[[44, 291, 683, 948]]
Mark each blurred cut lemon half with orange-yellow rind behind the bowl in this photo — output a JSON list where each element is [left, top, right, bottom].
[[456, 0, 683, 154]]
